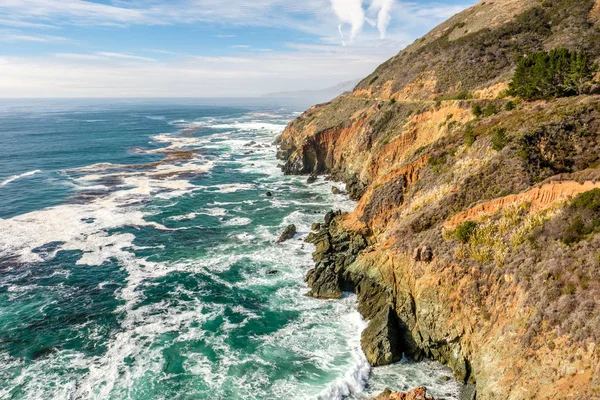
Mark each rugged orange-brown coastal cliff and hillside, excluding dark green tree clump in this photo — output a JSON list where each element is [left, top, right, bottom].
[[278, 0, 600, 399]]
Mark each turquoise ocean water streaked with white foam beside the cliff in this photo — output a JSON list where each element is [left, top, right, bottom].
[[0, 100, 458, 399]]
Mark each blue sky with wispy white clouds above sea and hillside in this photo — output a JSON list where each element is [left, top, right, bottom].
[[0, 0, 476, 98]]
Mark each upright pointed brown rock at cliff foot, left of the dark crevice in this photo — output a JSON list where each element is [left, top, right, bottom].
[[360, 305, 404, 367]]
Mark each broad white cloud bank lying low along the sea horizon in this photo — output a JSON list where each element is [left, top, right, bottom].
[[0, 46, 390, 97]]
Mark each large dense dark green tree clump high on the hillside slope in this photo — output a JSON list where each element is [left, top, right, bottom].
[[509, 48, 598, 100]]
